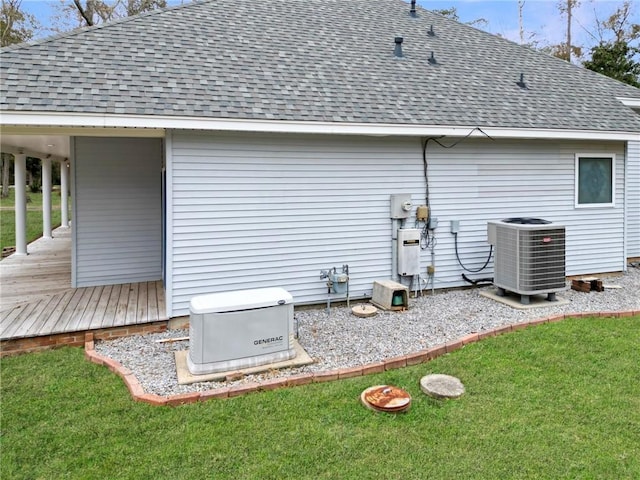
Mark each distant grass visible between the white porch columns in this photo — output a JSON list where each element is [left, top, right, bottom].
[[0, 189, 62, 249]]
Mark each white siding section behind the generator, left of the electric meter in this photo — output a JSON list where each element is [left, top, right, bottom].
[[172, 134, 424, 313]]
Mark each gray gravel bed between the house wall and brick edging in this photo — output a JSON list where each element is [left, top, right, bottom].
[[95, 267, 640, 395]]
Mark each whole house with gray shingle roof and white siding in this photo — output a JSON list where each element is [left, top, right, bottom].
[[0, 0, 640, 317]]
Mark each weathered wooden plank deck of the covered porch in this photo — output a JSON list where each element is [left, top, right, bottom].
[[0, 228, 167, 340]]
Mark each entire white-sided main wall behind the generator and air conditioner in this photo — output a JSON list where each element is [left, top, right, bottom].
[[168, 132, 624, 316]]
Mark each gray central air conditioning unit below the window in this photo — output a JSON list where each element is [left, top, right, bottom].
[[487, 218, 566, 305]]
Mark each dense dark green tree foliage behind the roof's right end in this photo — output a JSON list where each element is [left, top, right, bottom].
[[583, 41, 640, 88]]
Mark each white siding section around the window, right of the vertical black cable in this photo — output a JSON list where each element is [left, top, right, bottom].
[[423, 139, 624, 287]]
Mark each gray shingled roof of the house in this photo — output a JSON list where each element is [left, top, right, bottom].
[[0, 0, 640, 132]]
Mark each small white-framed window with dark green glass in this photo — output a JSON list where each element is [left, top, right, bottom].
[[576, 154, 615, 207]]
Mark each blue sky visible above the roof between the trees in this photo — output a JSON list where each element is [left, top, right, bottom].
[[22, 0, 640, 55]]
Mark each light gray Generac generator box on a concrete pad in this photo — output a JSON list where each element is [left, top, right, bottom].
[[187, 288, 296, 375]]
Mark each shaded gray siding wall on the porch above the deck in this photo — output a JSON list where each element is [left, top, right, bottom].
[[72, 137, 162, 287]]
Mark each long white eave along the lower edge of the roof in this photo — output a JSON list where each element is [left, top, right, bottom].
[[0, 111, 640, 141]]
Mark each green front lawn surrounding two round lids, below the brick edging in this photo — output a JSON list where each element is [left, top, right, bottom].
[[0, 317, 640, 480]]
